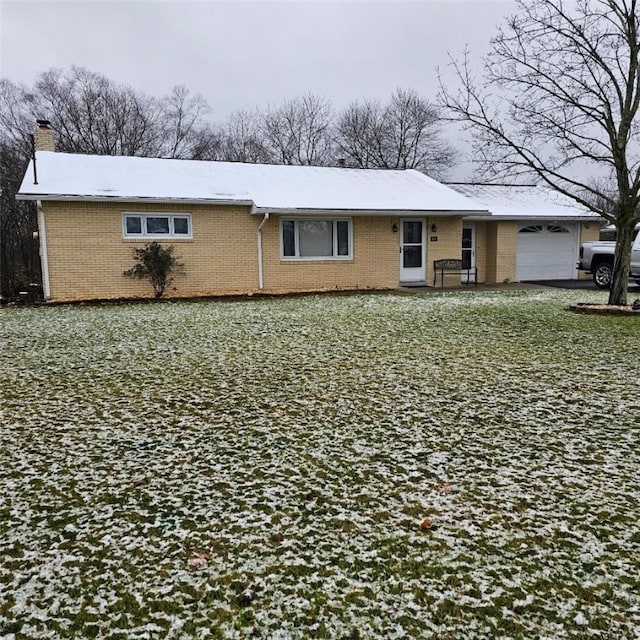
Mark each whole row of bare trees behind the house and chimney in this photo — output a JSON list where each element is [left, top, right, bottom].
[[0, 67, 456, 298]]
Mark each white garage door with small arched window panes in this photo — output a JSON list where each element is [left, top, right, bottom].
[[516, 222, 578, 280]]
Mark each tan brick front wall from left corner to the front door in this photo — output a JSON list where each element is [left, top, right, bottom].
[[43, 202, 410, 300]]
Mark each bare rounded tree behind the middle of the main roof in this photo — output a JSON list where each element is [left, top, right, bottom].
[[263, 93, 334, 165]]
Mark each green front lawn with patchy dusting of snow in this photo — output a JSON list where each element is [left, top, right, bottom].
[[0, 290, 640, 640]]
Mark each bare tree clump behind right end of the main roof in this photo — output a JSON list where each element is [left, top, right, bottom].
[[336, 89, 455, 176]]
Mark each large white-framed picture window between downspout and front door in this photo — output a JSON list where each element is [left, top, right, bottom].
[[281, 218, 351, 260]]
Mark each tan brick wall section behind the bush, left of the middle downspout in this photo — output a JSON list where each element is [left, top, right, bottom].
[[43, 202, 259, 300]]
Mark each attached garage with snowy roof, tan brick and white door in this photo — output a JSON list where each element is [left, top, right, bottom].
[[448, 183, 601, 282]]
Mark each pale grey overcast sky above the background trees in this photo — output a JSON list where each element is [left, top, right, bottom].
[[0, 0, 515, 178]]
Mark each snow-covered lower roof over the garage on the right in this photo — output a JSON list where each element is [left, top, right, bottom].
[[449, 183, 600, 220]]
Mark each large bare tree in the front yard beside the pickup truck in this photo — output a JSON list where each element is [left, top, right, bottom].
[[441, 0, 640, 304]]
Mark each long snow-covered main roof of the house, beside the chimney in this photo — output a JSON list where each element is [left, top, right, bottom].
[[17, 151, 488, 215]]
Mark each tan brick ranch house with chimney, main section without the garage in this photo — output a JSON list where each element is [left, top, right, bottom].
[[17, 121, 598, 301]]
